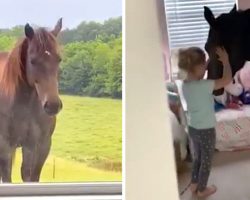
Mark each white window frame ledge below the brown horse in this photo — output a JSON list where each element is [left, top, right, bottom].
[[0, 182, 122, 199]]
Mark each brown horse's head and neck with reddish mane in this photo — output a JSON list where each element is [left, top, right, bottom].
[[0, 19, 62, 116]]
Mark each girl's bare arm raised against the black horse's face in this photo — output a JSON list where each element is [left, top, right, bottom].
[[214, 47, 232, 90]]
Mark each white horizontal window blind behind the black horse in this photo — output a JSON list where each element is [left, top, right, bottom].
[[165, 0, 235, 50]]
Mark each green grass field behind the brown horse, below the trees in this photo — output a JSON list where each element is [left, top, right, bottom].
[[13, 96, 122, 182]]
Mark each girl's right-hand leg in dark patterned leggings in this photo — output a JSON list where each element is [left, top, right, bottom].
[[197, 129, 216, 192]]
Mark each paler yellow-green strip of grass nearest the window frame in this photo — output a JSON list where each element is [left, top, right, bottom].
[[12, 148, 121, 183]]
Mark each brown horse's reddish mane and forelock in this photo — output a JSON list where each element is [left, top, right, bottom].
[[0, 28, 59, 99]]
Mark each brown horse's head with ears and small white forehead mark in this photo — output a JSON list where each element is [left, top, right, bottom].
[[25, 19, 62, 115]]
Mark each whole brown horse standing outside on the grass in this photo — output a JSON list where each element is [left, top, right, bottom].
[[0, 19, 62, 182]]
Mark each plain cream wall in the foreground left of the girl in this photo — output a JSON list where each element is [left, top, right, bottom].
[[124, 0, 178, 200]]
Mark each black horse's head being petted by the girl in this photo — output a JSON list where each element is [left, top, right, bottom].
[[204, 5, 250, 95]]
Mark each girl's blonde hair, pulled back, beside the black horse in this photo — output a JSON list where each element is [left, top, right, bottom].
[[178, 47, 206, 72]]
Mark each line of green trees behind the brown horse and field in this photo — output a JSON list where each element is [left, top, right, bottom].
[[0, 17, 122, 98]]
